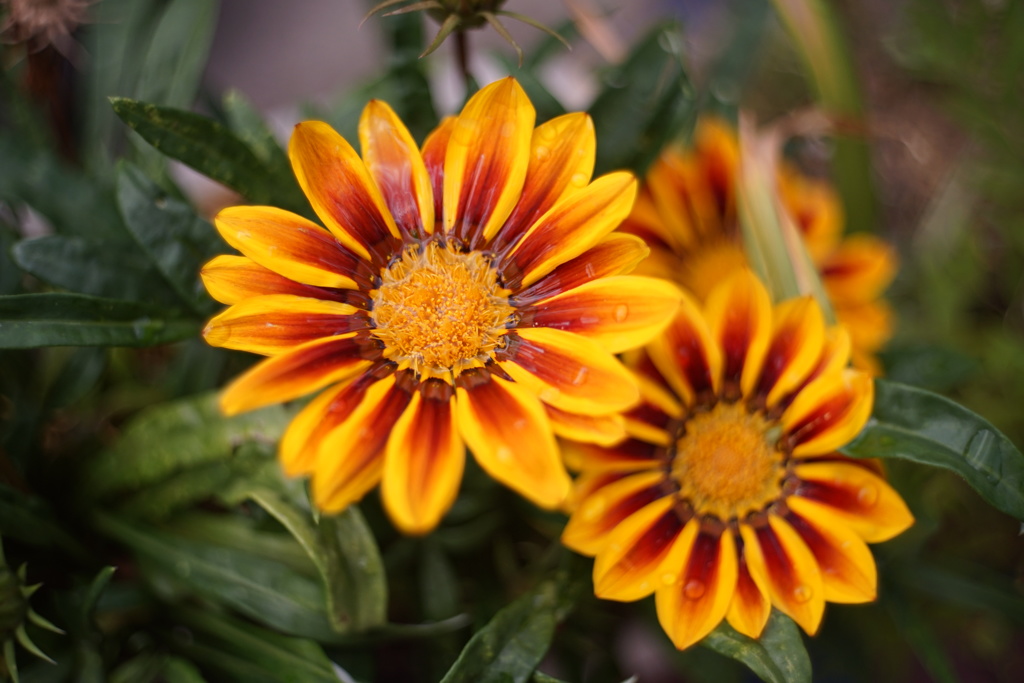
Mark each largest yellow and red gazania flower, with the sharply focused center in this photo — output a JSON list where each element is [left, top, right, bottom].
[[203, 79, 679, 533]]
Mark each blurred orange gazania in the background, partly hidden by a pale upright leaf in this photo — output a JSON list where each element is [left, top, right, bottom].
[[623, 118, 896, 373]]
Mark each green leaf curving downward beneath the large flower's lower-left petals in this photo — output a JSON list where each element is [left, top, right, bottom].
[[249, 489, 387, 634]]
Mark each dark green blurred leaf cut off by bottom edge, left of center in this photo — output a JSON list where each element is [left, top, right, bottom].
[[172, 607, 339, 683]]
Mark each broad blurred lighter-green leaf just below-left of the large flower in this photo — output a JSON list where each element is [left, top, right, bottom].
[[84, 394, 291, 496]]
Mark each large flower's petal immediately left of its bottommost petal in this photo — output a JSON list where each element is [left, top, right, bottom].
[[312, 375, 412, 512]]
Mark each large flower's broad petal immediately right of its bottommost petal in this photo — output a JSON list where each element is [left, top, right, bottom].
[[456, 373, 570, 508]]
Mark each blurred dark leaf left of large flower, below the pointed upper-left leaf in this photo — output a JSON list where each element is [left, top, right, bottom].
[[117, 164, 228, 314]]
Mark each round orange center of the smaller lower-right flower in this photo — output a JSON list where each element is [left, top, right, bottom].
[[672, 402, 784, 521]]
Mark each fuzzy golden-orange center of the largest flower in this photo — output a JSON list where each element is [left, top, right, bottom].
[[371, 242, 515, 379]]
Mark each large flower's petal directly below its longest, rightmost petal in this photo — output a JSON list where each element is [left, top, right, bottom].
[[498, 328, 640, 415]]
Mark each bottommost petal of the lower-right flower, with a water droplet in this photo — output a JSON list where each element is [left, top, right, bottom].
[[655, 529, 737, 650]]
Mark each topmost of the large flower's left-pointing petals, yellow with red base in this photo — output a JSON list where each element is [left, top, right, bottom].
[[213, 206, 374, 289]]
